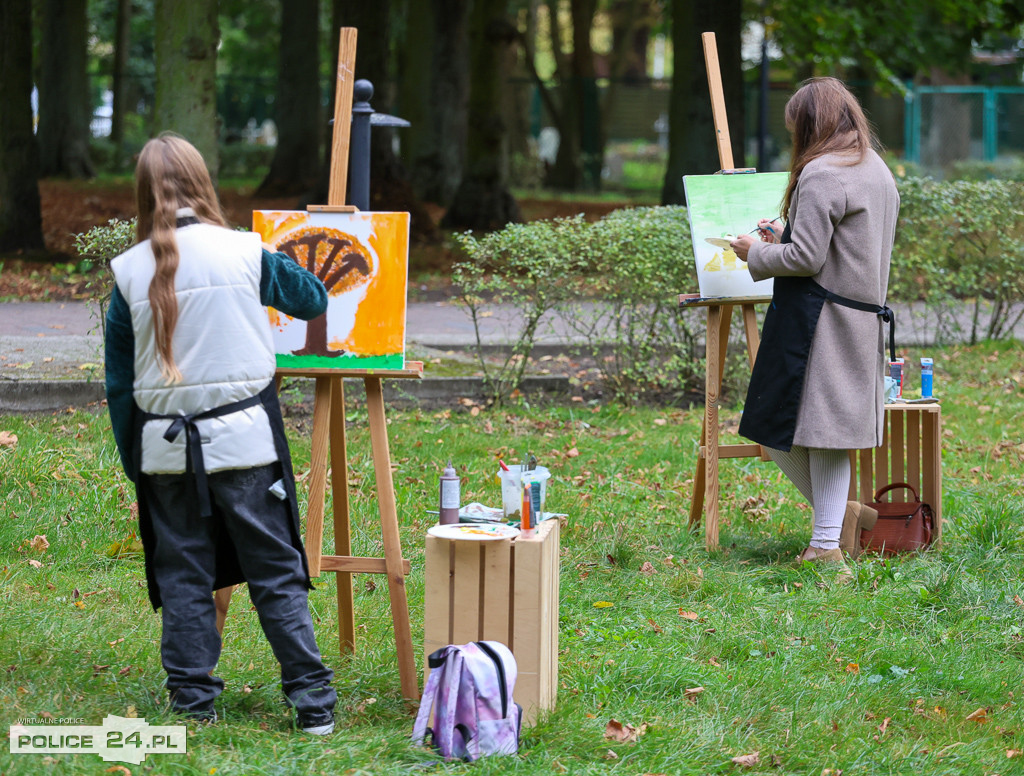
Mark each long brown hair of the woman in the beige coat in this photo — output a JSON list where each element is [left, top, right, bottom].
[[782, 78, 878, 220]]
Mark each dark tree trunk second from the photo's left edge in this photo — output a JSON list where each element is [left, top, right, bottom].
[[39, 0, 93, 178]]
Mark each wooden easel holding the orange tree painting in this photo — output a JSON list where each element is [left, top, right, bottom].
[[216, 28, 423, 700]]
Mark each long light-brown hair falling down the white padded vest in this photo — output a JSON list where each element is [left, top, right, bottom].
[[135, 137, 226, 383]]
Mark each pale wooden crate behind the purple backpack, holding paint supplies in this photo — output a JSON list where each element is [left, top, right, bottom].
[[423, 519, 559, 725]]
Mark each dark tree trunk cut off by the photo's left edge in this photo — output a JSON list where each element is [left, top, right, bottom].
[[0, 0, 43, 253]]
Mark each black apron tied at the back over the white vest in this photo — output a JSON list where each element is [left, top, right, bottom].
[[134, 380, 312, 609]]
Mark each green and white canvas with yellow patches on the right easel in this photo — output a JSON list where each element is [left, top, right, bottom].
[[683, 172, 790, 298]]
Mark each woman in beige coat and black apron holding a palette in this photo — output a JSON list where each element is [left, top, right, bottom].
[[731, 78, 899, 576]]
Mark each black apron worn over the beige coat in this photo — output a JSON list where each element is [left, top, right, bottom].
[[739, 225, 896, 451]]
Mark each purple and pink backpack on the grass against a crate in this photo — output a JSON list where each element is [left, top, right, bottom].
[[413, 641, 522, 761]]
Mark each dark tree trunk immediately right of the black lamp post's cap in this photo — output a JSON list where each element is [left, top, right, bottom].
[[399, 0, 470, 205]]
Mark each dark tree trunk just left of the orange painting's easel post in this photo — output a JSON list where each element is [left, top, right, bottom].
[[256, 0, 319, 197]]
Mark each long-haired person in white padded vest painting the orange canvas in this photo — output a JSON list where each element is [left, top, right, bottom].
[[105, 133, 337, 735]]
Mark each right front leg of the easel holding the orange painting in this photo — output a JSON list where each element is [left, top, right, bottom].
[[365, 377, 420, 700]]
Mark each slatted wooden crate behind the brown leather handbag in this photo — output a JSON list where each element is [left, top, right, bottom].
[[850, 403, 942, 544]]
